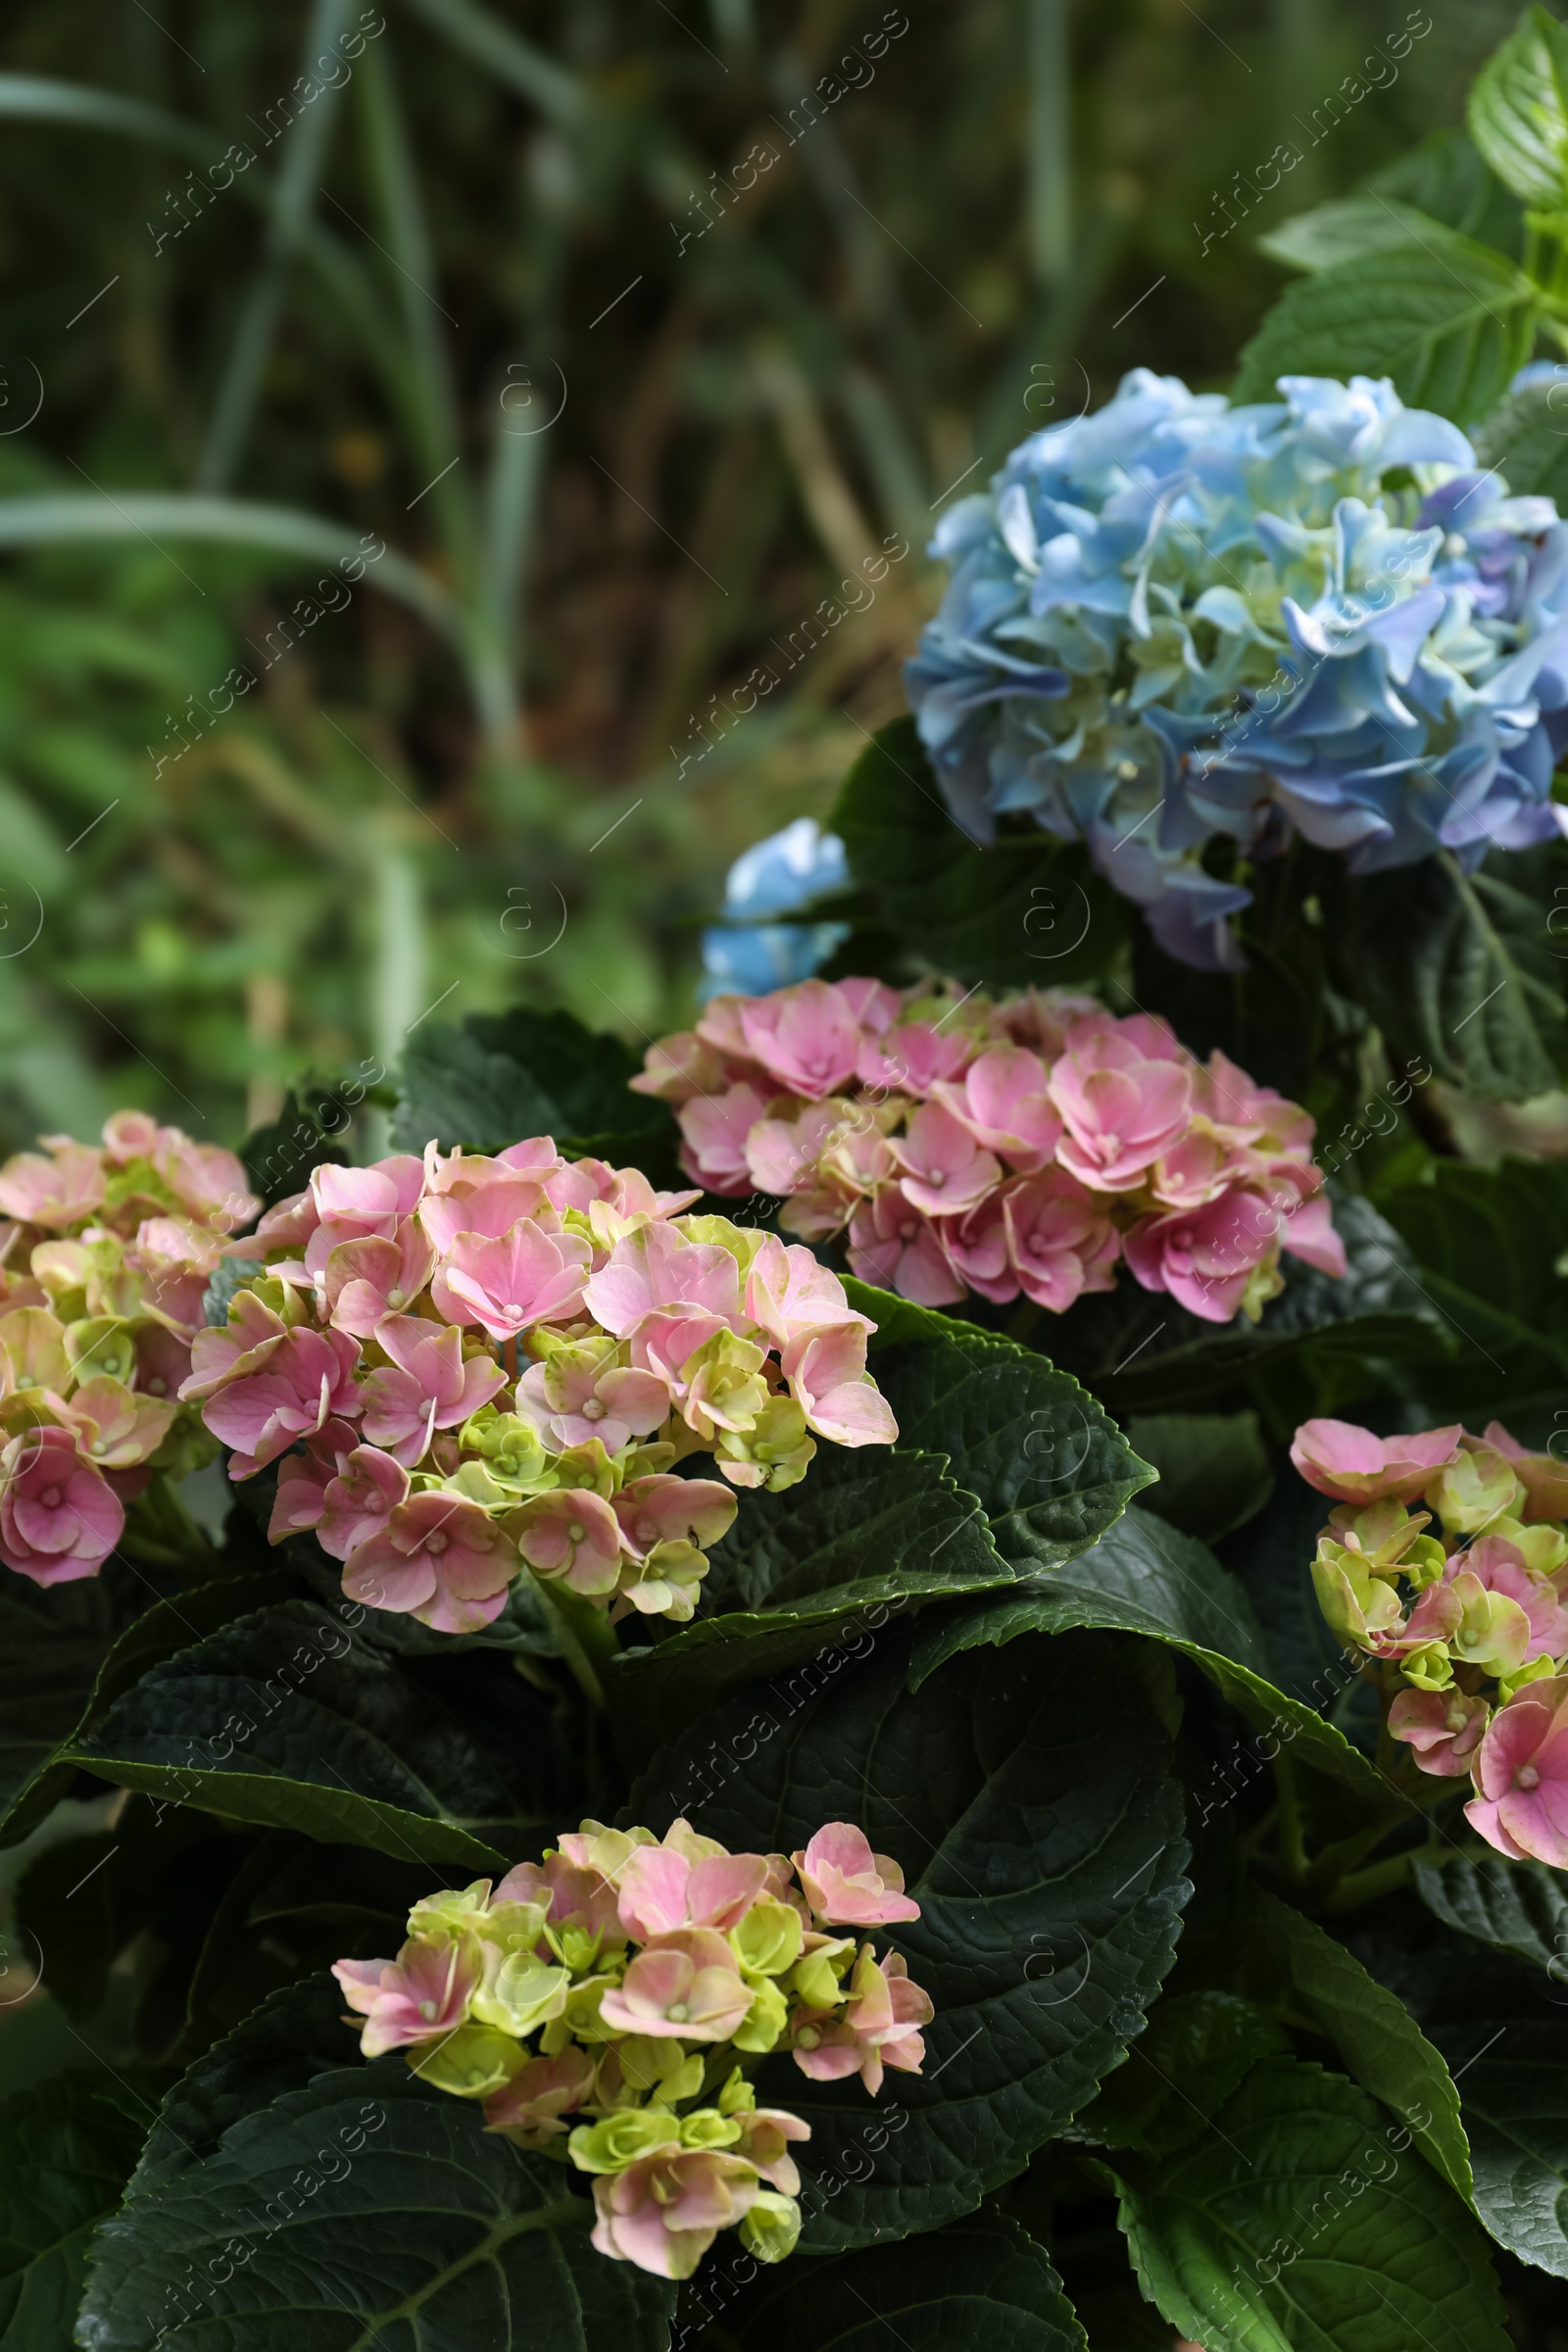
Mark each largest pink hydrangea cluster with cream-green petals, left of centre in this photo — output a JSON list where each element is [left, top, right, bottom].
[[181, 1136, 898, 1633]]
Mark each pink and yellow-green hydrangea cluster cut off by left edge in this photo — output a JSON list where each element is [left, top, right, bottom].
[[0, 1110, 261, 1586]]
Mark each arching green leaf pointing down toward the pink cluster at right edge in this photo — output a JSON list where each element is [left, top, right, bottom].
[[912, 1507, 1403, 1818]]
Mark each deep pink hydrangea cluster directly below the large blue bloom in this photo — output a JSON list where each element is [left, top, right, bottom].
[[632, 981, 1345, 1322]]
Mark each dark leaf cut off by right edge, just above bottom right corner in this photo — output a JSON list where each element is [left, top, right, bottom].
[[1441, 2018, 1568, 2279]]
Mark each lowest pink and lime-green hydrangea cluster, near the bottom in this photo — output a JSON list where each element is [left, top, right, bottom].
[[334, 1821, 931, 2279]]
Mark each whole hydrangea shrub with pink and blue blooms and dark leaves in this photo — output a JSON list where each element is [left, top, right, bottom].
[[15, 7, 1568, 2352]]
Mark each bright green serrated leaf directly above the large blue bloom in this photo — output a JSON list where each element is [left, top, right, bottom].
[[1234, 223, 1540, 423]]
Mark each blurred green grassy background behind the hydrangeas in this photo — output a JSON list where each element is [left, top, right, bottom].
[[0, 0, 1514, 1151]]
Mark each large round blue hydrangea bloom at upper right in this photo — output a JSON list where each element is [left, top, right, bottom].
[[906, 367, 1568, 969]]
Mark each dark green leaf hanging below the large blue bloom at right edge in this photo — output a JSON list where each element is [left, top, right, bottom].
[[1324, 849, 1568, 1103]]
